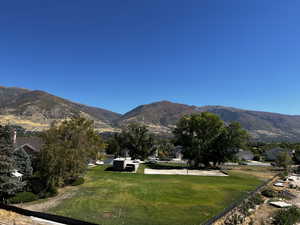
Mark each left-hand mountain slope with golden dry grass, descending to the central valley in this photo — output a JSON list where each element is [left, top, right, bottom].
[[0, 87, 120, 131]]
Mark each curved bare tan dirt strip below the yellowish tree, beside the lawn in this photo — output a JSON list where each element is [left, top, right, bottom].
[[17, 186, 78, 212]]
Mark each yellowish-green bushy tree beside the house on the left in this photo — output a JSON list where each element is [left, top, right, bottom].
[[39, 117, 104, 187]]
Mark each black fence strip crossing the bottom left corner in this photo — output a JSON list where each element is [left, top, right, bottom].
[[0, 204, 98, 225]]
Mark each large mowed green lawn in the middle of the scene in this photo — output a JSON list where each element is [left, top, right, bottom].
[[50, 166, 262, 225]]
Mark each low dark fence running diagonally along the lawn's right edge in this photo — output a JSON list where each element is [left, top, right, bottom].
[[202, 174, 278, 225]]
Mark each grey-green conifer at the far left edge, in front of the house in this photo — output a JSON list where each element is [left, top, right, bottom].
[[0, 125, 23, 201]]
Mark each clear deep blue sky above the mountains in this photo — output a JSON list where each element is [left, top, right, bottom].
[[0, 0, 300, 114]]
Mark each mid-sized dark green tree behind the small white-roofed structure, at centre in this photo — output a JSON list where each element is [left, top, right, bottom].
[[110, 123, 155, 159]]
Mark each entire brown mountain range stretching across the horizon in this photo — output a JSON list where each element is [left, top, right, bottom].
[[0, 87, 300, 142]]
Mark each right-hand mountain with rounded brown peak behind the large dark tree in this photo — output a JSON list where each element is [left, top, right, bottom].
[[117, 101, 300, 141]]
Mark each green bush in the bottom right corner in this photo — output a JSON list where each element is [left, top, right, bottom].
[[273, 206, 300, 225]]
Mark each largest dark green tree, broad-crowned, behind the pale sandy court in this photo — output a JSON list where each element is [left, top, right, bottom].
[[173, 112, 247, 167]]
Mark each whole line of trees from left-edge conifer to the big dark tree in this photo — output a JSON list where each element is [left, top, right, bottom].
[[0, 112, 268, 201]]
